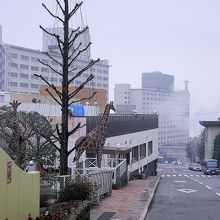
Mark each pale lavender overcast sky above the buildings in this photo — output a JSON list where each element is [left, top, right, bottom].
[[0, 0, 220, 136]]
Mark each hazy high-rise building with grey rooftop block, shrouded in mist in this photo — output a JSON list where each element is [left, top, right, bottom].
[[114, 72, 190, 150]]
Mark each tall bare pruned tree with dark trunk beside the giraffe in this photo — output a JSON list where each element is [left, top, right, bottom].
[[35, 0, 99, 175]]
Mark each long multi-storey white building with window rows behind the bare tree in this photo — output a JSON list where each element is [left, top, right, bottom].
[[0, 28, 109, 99]]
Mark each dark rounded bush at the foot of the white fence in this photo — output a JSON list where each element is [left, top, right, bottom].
[[59, 177, 93, 202]]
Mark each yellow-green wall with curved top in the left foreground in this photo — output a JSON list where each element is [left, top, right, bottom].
[[0, 148, 40, 220]]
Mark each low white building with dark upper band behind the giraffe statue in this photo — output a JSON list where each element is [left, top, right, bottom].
[[86, 114, 158, 175]]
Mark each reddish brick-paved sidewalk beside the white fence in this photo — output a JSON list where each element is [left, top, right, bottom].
[[90, 177, 152, 220]]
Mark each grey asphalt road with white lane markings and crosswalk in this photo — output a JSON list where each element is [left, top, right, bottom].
[[145, 164, 220, 220]]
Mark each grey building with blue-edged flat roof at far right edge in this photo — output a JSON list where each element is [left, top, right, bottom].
[[199, 121, 220, 158]]
